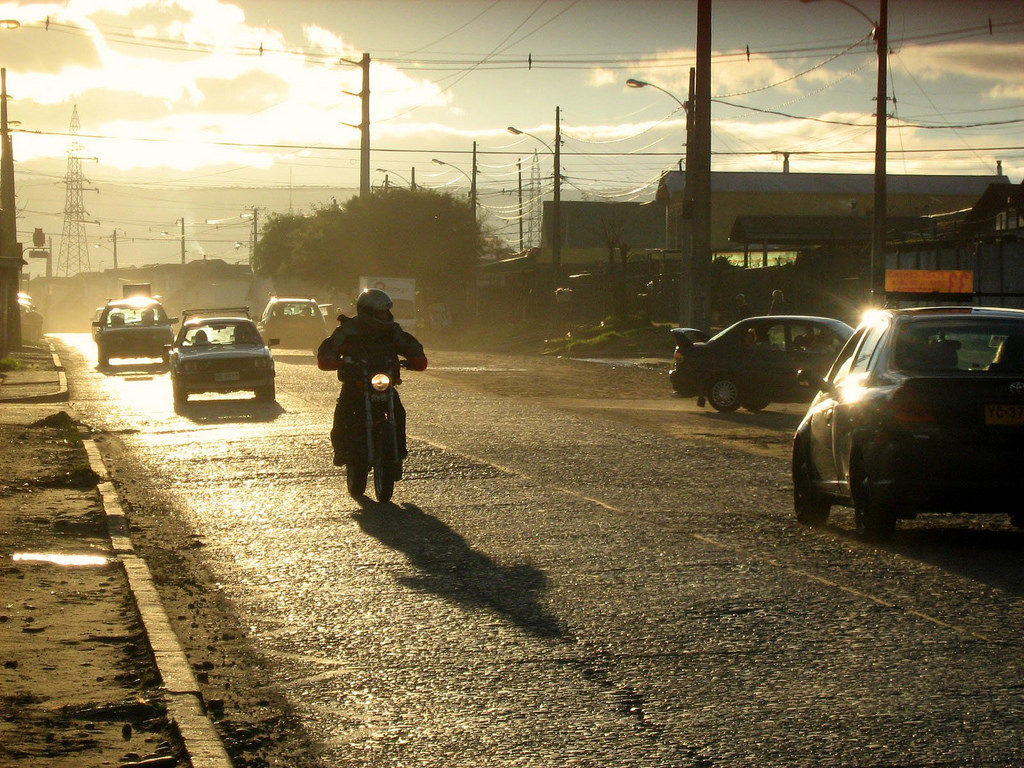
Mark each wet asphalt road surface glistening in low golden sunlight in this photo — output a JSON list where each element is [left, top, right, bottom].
[[61, 335, 1024, 768]]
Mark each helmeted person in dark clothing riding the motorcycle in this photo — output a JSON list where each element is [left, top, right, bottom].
[[316, 288, 427, 467]]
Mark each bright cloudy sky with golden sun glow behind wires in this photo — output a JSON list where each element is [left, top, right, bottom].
[[0, 0, 1024, 266]]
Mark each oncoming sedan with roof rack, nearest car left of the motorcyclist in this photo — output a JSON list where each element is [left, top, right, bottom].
[[169, 307, 278, 408]]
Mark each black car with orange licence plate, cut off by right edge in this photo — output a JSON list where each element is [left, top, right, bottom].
[[793, 307, 1024, 539]]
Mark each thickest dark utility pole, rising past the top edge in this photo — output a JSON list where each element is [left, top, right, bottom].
[[686, 0, 712, 330]]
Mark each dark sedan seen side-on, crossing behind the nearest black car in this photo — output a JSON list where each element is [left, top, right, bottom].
[[669, 315, 853, 411]]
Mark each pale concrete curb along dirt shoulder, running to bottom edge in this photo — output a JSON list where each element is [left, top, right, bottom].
[[83, 435, 231, 768]]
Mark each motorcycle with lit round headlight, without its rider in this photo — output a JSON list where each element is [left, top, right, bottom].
[[343, 356, 406, 504]]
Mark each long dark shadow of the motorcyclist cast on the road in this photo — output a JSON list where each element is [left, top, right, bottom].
[[352, 499, 566, 638]]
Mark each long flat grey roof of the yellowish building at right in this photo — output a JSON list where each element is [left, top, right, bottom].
[[657, 171, 1010, 202]]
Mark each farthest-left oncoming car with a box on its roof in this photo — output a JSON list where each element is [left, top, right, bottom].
[[92, 296, 177, 367]]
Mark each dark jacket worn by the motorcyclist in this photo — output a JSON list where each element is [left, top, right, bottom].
[[316, 315, 427, 381]]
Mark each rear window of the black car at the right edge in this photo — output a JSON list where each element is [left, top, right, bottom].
[[893, 317, 1024, 374]]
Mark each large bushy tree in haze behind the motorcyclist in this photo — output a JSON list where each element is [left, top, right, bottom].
[[253, 187, 483, 310]]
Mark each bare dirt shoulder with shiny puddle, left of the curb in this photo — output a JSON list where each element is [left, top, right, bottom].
[[0, 406, 188, 768]]
